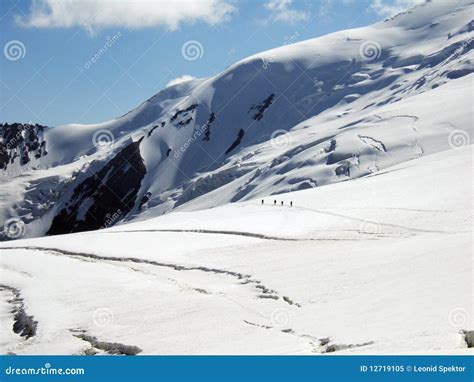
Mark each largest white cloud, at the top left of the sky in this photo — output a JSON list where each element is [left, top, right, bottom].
[[16, 0, 235, 32]]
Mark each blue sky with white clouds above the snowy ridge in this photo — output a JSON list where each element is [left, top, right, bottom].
[[0, 0, 416, 126]]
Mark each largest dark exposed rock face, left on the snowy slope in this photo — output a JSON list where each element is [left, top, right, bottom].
[[47, 139, 146, 235]]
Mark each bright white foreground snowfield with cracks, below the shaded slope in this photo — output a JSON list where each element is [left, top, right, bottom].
[[0, 146, 473, 354]]
